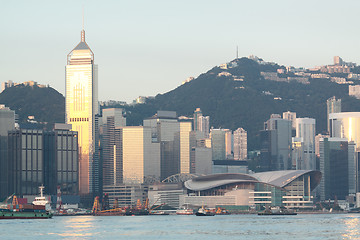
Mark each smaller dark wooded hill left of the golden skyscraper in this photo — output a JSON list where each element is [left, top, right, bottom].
[[0, 84, 65, 127]]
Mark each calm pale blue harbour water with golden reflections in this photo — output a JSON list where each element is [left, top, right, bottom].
[[0, 214, 360, 240]]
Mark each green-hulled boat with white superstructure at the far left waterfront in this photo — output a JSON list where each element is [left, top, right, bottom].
[[0, 187, 53, 219]]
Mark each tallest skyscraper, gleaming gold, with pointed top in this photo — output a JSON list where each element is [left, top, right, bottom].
[[65, 29, 99, 194]]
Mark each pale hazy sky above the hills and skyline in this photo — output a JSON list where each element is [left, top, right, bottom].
[[0, 0, 360, 102]]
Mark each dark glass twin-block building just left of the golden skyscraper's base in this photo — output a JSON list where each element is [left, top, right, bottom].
[[8, 129, 79, 195]]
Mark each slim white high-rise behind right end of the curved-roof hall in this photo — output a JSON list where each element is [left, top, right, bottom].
[[296, 118, 316, 170]]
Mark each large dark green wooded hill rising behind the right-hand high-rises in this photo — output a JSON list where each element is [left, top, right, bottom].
[[128, 58, 360, 149]]
